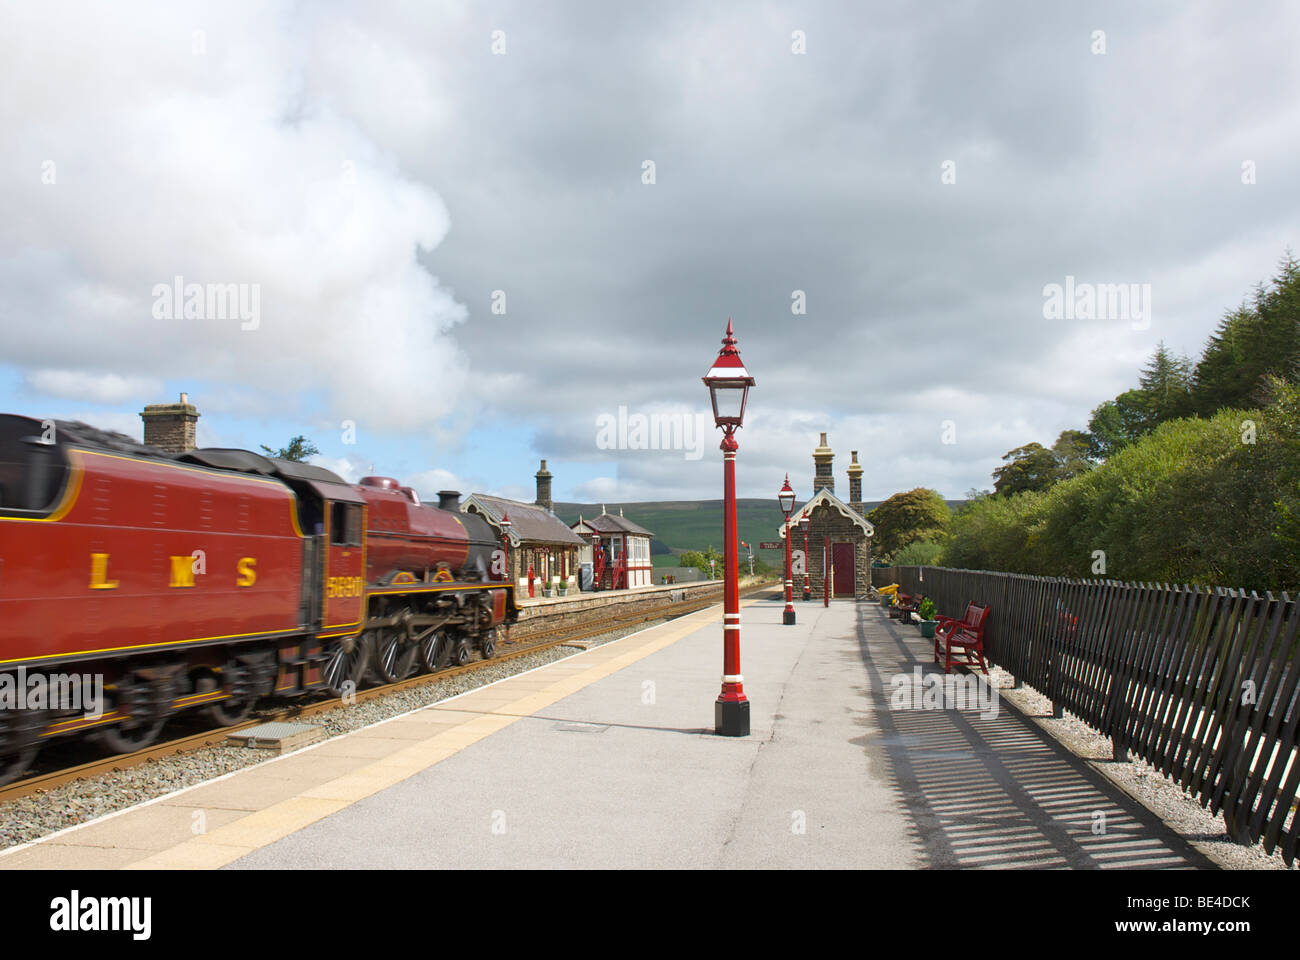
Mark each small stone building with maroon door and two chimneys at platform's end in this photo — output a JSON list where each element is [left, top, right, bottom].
[[779, 433, 876, 600]]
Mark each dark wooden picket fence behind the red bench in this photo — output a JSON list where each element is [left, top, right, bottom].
[[871, 567, 1300, 865]]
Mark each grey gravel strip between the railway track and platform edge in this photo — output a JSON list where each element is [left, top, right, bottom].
[[0, 618, 668, 849]]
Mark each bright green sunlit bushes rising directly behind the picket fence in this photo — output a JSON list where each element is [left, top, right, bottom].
[[943, 380, 1300, 591]]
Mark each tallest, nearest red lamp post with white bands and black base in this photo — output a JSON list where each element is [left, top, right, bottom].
[[702, 319, 754, 736]]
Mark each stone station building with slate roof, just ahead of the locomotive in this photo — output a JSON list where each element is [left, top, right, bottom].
[[460, 460, 585, 591]]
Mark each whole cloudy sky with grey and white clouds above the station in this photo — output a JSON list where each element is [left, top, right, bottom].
[[0, 1, 1300, 503]]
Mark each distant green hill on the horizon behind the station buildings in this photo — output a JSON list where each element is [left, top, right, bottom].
[[555, 497, 962, 570]]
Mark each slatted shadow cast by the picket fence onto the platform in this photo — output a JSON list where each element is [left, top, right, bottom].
[[858, 604, 1214, 869]]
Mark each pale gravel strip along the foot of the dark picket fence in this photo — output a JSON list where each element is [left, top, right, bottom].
[[989, 667, 1300, 870]]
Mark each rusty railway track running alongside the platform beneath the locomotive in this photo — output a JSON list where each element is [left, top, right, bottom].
[[0, 584, 774, 804]]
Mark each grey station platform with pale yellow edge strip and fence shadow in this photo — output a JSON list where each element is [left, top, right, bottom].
[[0, 598, 1212, 869]]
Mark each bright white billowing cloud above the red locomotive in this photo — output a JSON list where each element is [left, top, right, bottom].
[[0, 4, 467, 432]]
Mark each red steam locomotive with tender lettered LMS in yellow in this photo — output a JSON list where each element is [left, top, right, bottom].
[[0, 415, 517, 783]]
